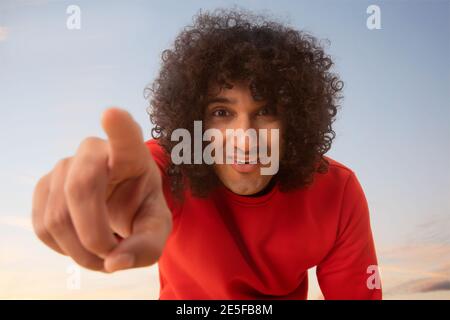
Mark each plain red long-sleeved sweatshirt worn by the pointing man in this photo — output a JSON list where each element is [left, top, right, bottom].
[[147, 140, 381, 299]]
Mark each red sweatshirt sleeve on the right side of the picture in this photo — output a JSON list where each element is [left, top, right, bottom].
[[316, 172, 382, 300]]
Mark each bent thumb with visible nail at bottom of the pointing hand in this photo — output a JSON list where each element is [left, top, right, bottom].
[[104, 192, 172, 272]]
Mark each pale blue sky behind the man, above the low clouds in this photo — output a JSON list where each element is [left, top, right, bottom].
[[0, 0, 450, 300]]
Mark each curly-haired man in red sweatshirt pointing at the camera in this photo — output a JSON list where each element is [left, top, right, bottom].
[[33, 11, 381, 299]]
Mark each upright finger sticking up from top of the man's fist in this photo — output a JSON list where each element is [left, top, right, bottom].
[[102, 108, 150, 182]]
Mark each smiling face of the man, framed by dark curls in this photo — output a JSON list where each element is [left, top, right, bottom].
[[205, 83, 282, 195]]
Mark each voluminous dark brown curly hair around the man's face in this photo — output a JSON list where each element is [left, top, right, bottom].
[[146, 9, 343, 200]]
